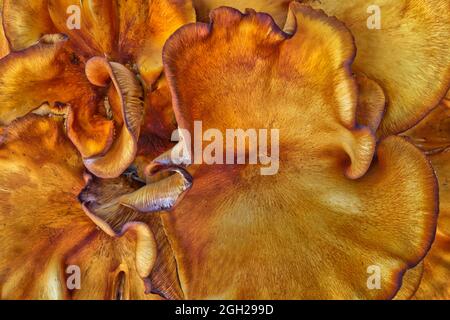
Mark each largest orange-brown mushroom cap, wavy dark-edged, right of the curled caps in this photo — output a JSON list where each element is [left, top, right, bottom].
[[157, 3, 437, 299]]
